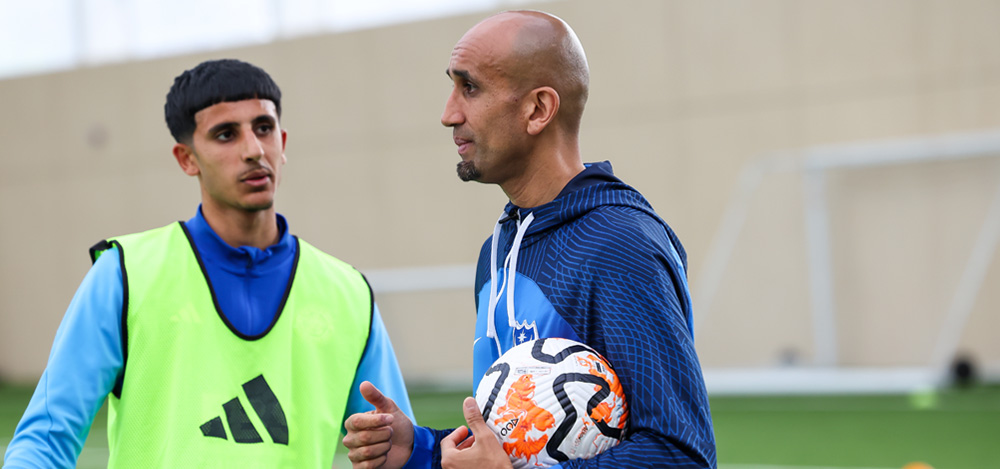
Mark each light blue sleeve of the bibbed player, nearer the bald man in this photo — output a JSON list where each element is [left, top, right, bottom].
[[344, 305, 416, 424]]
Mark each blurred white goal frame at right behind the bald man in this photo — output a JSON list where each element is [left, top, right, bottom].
[[692, 131, 1000, 394]]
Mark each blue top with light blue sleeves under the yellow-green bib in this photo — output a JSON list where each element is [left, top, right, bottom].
[[4, 207, 413, 469]]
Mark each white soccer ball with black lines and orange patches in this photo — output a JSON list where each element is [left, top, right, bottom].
[[476, 338, 628, 469]]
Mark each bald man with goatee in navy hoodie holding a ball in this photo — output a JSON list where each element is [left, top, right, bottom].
[[344, 11, 716, 469]]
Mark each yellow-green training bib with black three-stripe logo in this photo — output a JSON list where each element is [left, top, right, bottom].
[[96, 223, 372, 469]]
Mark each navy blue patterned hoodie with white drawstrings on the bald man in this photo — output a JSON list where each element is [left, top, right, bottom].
[[410, 162, 716, 469]]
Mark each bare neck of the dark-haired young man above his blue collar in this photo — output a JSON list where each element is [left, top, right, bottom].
[[201, 204, 279, 249]]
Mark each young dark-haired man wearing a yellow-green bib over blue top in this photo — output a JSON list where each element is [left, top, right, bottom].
[[5, 60, 412, 468]]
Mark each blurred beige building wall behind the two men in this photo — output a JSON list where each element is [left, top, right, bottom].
[[0, 0, 1000, 382]]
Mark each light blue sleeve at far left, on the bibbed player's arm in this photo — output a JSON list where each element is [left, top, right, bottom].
[[4, 249, 122, 469]]
